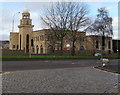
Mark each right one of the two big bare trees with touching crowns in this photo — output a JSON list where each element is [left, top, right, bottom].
[[69, 3, 89, 56]]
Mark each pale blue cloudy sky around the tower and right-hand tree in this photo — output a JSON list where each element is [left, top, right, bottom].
[[0, 2, 118, 40]]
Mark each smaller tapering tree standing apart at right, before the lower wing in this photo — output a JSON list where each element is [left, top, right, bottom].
[[86, 7, 113, 53]]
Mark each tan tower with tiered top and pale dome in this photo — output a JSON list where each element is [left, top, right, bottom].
[[18, 9, 34, 53]]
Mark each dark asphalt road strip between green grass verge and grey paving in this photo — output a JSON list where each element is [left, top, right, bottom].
[[2, 59, 100, 72]]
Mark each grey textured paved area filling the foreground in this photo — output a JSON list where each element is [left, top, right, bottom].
[[2, 67, 118, 93]]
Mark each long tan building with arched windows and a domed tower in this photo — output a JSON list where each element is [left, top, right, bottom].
[[9, 11, 112, 54]]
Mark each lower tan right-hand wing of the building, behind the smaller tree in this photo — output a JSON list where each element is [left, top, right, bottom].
[[86, 35, 113, 54]]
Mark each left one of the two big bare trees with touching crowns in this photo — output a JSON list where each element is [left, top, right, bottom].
[[41, 2, 71, 54]]
